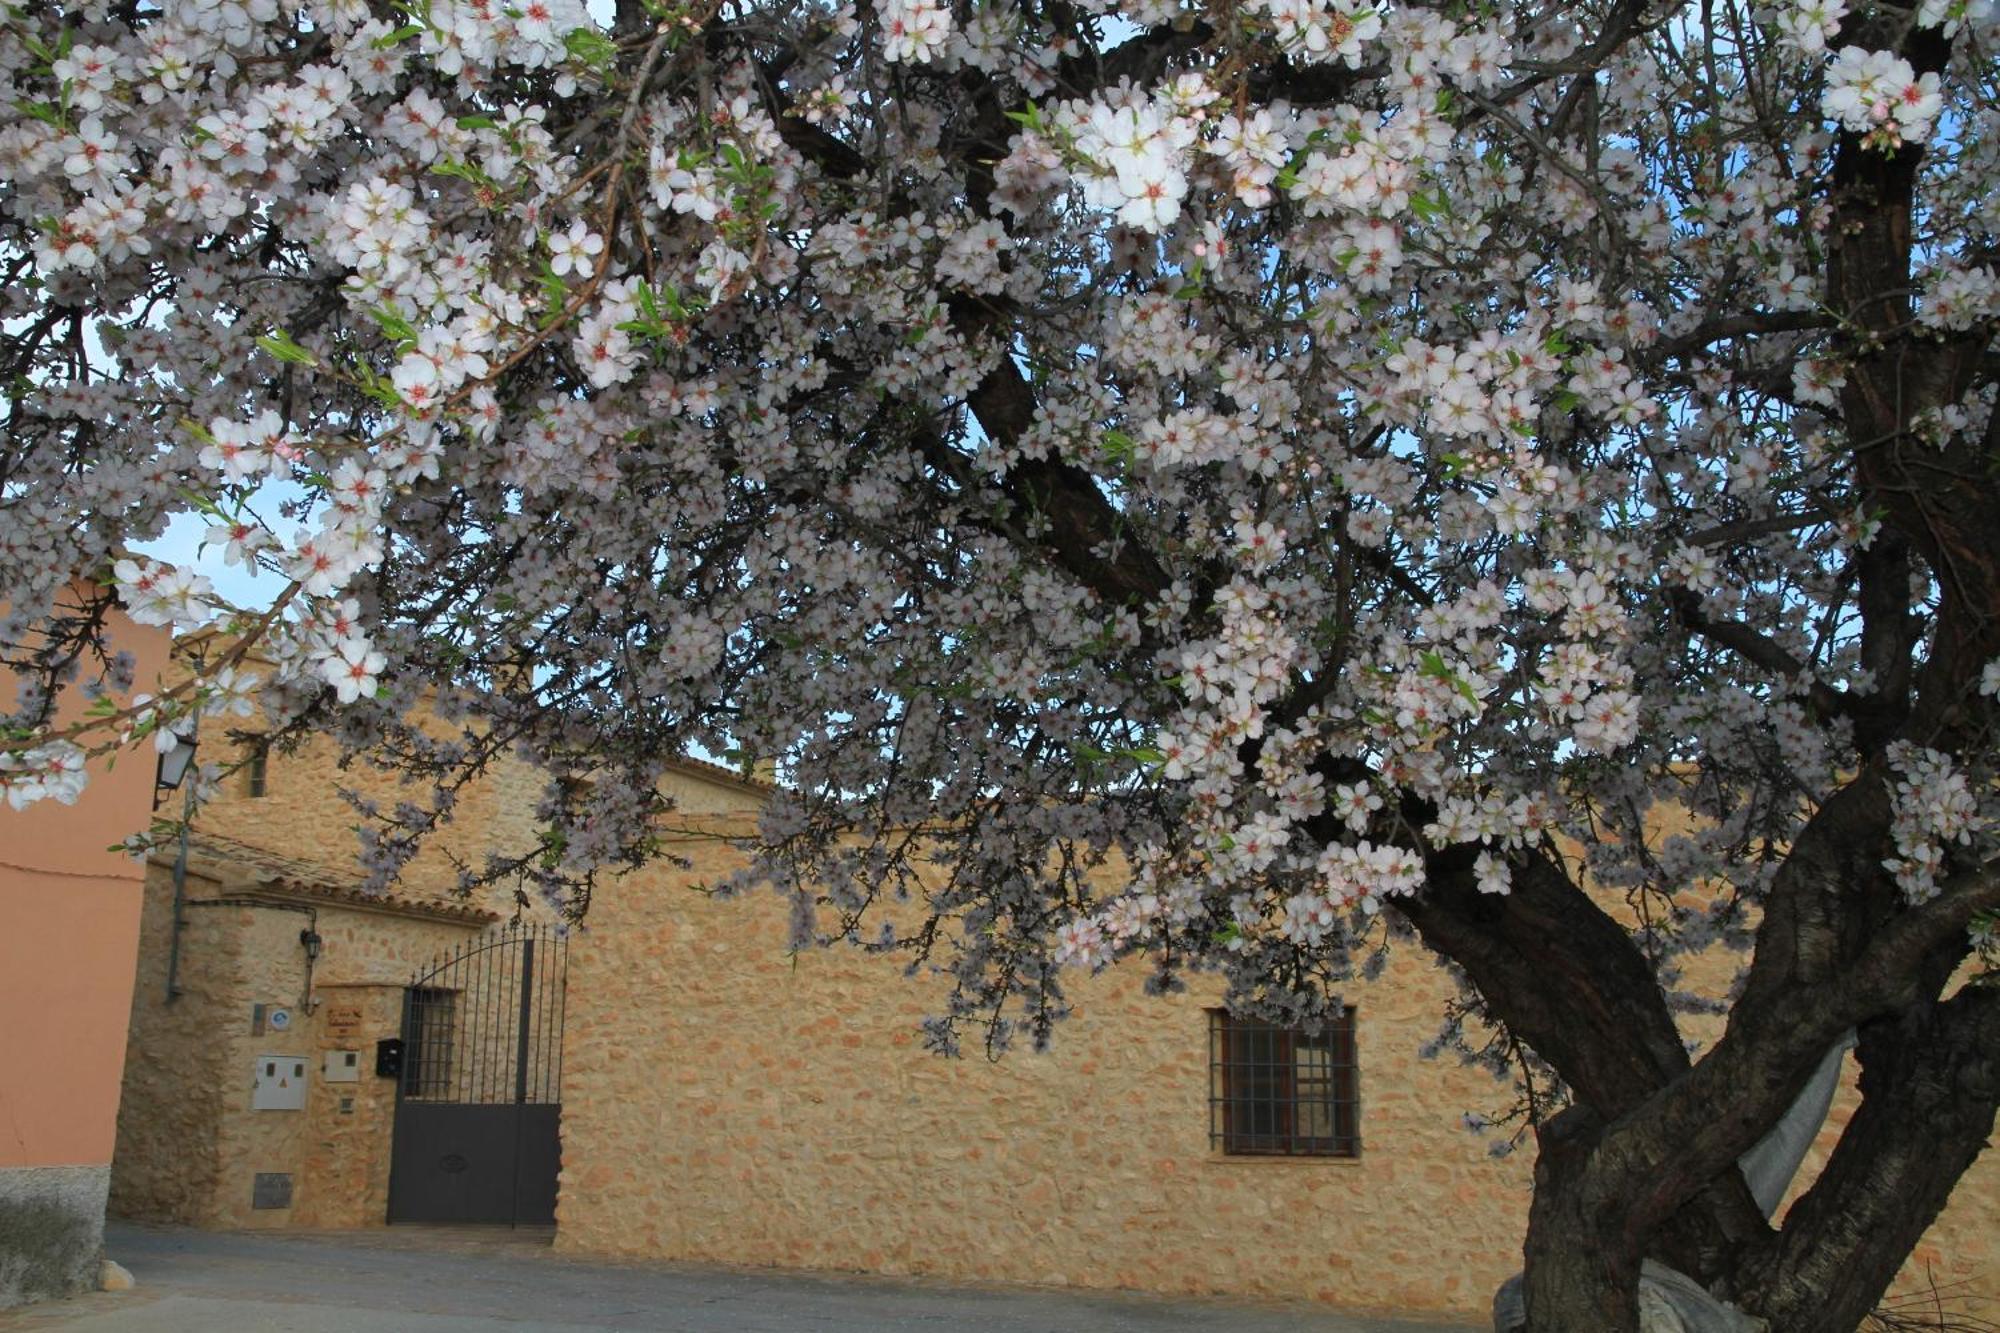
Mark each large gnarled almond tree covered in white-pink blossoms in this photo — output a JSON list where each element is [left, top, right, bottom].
[[0, 0, 2000, 1333]]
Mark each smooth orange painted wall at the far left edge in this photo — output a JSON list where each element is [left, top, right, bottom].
[[0, 592, 170, 1169]]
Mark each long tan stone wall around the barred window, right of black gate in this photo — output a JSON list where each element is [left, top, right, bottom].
[[558, 816, 2000, 1317]]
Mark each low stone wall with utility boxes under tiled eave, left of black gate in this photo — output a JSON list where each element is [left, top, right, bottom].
[[112, 865, 482, 1227]]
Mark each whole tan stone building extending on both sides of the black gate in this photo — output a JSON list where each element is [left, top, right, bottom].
[[114, 720, 2000, 1317]]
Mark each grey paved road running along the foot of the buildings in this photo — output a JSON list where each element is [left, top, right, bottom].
[[0, 1223, 1476, 1333]]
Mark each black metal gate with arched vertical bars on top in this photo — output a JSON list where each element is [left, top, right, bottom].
[[388, 925, 568, 1225]]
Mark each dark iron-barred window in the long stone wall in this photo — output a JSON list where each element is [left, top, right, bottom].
[[1208, 1009, 1362, 1157]]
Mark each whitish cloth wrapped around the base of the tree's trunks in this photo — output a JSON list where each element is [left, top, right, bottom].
[[1494, 1031, 1854, 1333]]
